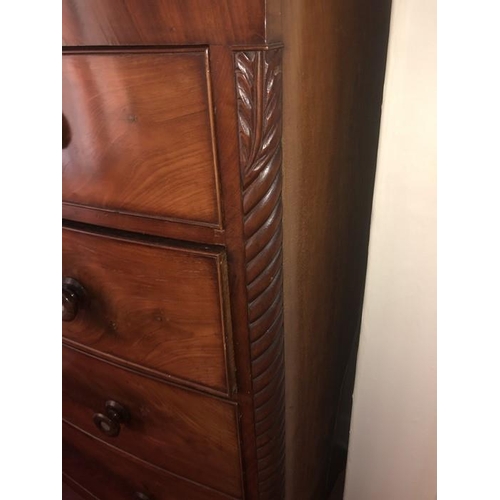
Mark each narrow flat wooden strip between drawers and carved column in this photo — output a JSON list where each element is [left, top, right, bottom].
[[210, 47, 259, 500]]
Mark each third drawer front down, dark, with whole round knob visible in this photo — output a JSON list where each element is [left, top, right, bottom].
[[62, 347, 241, 497]]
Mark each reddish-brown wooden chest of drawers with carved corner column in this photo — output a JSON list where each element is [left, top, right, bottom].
[[62, 0, 389, 500]]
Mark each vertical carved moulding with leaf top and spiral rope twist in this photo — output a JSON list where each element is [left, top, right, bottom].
[[235, 49, 285, 500]]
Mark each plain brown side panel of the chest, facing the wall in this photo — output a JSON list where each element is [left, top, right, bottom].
[[283, 0, 390, 500]]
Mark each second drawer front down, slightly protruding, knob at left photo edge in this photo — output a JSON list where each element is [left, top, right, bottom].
[[62, 229, 229, 394]]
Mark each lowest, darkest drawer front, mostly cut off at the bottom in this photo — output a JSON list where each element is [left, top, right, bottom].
[[62, 423, 234, 500]]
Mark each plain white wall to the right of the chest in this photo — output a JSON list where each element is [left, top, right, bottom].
[[344, 0, 436, 500]]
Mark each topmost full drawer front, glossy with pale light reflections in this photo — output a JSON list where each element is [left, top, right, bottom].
[[62, 50, 221, 227]]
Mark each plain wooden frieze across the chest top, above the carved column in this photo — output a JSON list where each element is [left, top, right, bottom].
[[62, 0, 281, 45]]
